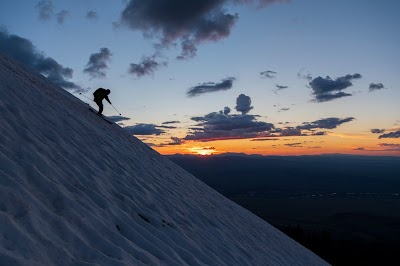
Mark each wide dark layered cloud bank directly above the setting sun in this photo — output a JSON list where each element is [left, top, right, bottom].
[[185, 112, 274, 141]]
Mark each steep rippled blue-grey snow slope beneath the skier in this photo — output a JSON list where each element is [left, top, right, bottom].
[[0, 53, 327, 265]]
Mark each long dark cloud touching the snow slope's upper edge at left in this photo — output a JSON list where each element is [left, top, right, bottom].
[[0, 29, 85, 92]]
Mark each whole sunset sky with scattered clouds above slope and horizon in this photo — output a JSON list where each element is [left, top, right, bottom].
[[0, 0, 400, 156]]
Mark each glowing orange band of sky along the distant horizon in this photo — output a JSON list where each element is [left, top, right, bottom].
[[153, 134, 400, 156]]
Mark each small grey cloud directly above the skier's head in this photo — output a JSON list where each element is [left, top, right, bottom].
[[83, 47, 112, 78]]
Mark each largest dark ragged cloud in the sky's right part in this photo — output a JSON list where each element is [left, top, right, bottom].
[[309, 73, 361, 102]]
